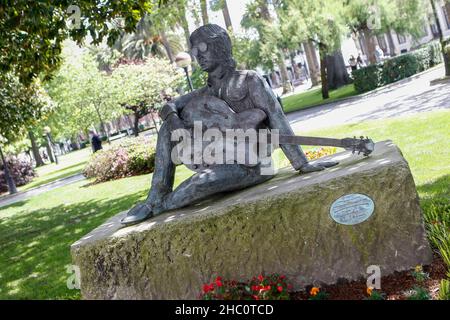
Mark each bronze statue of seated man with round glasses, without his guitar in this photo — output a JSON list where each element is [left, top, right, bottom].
[[121, 24, 337, 225]]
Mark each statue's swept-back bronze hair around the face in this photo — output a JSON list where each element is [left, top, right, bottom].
[[189, 24, 236, 69]]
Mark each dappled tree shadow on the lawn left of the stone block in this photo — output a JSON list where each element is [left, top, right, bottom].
[[0, 192, 145, 299]]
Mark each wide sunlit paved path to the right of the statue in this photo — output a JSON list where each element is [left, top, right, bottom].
[[287, 67, 450, 131]]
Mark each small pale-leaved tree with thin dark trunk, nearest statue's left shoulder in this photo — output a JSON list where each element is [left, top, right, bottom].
[[109, 58, 184, 136]]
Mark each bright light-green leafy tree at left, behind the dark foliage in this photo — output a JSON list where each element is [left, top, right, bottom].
[[46, 44, 123, 141]]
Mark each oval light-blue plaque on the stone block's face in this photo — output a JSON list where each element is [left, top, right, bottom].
[[330, 193, 375, 225]]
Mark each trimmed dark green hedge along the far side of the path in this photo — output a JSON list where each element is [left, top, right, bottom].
[[352, 42, 442, 93]]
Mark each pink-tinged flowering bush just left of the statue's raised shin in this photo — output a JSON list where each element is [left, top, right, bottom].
[[83, 138, 155, 183]]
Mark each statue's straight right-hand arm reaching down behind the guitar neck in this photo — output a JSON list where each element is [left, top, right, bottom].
[[247, 71, 308, 170]]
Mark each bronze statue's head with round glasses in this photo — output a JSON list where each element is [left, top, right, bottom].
[[190, 24, 236, 72]]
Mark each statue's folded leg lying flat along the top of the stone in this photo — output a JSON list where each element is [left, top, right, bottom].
[[153, 164, 273, 214]]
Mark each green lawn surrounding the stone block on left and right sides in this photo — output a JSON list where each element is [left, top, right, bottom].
[[0, 112, 450, 299]]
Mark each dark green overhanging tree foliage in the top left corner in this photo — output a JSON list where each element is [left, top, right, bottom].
[[0, 0, 156, 84]]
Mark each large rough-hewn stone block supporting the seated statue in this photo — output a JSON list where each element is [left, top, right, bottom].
[[71, 141, 432, 299]]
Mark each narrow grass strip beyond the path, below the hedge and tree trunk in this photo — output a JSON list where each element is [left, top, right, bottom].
[[282, 84, 358, 113]]
